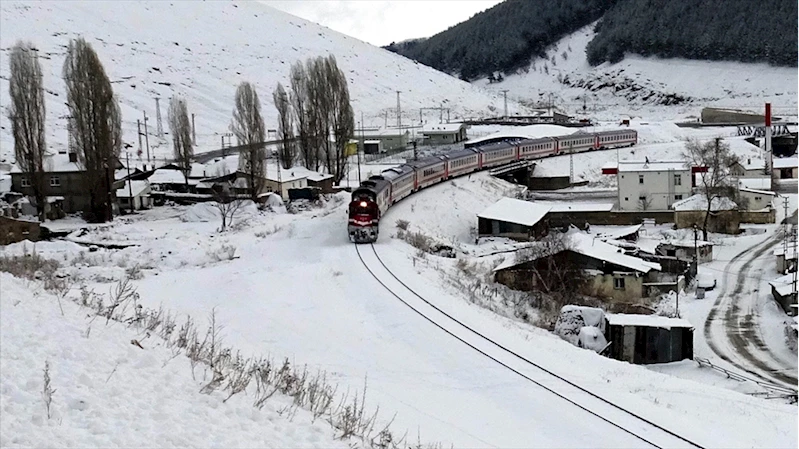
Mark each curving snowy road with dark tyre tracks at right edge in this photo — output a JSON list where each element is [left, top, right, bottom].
[[704, 228, 797, 388]]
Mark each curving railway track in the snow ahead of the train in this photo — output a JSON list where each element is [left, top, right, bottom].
[[355, 244, 703, 448]]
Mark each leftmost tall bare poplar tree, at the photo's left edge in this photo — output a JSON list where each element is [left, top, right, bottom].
[[8, 41, 47, 221]]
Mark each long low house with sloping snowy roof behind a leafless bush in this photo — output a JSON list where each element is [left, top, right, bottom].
[[494, 232, 664, 304]]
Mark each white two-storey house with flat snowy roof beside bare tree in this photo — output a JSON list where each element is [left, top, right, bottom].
[[603, 160, 691, 211]]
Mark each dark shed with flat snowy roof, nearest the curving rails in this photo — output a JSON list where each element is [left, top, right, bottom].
[[605, 313, 694, 365]]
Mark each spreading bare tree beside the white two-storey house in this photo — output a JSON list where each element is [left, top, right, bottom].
[[683, 137, 737, 241]]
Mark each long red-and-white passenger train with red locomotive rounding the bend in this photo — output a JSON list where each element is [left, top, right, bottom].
[[347, 129, 638, 243]]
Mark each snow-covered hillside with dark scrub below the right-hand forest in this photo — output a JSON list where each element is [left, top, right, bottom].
[[482, 24, 797, 120]]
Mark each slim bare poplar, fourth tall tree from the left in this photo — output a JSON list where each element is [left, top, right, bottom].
[[230, 81, 266, 201]]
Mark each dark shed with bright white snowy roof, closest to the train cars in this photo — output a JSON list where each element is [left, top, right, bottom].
[[477, 198, 550, 240]]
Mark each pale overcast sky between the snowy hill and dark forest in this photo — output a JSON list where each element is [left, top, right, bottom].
[[261, 0, 502, 46]]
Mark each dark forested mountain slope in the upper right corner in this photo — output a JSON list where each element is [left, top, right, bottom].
[[587, 0, 796, 67]]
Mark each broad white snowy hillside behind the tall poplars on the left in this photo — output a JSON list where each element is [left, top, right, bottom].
[[0, 0, 520, 163]]
